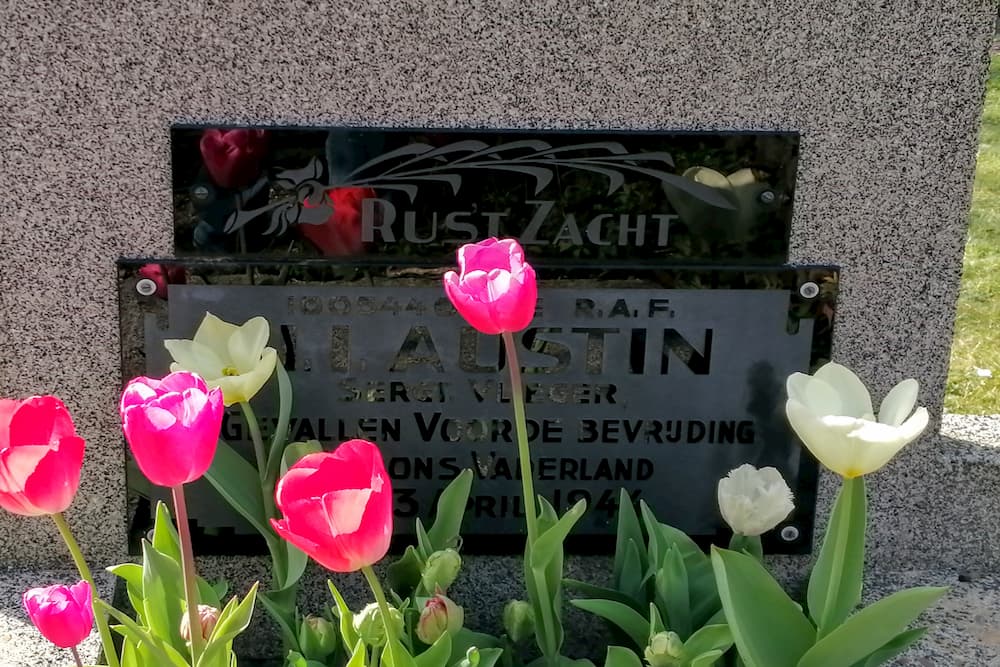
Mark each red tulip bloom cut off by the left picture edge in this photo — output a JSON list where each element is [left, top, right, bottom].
[[0, 396, 83, 516]]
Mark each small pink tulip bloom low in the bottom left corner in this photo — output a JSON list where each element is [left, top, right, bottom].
[[21, 581, 94, 648]]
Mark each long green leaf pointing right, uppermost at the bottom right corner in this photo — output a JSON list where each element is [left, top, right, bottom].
[[798, 586, 948, 667]]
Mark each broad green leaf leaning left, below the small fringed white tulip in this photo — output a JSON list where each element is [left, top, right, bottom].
[[712, 547, 816, 667]]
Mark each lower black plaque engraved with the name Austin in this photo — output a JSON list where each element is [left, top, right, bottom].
[[119, 260, 837, 552]]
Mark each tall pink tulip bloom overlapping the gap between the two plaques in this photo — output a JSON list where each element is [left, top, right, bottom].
[[444, 238, 538, 334]]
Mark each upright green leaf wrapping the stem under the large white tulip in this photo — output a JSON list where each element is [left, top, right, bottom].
[[806, 477, 867, 637]]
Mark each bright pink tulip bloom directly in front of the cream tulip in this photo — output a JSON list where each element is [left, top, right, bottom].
[[120, 371, 223, 487]]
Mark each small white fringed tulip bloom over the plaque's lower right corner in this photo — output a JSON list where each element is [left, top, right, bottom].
[[719, 463, 795, 537]]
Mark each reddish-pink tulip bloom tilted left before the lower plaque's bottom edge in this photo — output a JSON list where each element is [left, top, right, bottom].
[[271, 440, 392, 572]]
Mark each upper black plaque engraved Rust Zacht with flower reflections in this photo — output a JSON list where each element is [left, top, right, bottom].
[[171, 127, 798, 265]]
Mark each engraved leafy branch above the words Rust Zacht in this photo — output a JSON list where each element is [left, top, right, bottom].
[[225, 139, 732, 234]]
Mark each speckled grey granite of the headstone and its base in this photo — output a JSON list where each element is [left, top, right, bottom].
[[0, 0, 1000, 664]]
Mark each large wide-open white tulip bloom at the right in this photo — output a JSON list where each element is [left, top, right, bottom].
[[785, 363, 929, 479]]
